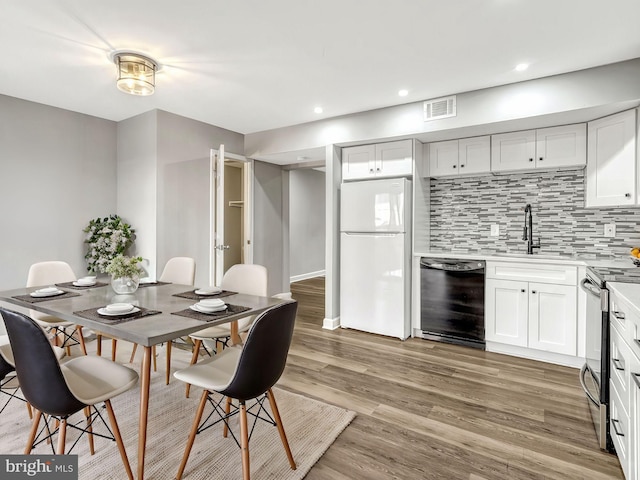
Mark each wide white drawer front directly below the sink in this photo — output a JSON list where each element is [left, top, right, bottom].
[[487, 262, 578, 285]]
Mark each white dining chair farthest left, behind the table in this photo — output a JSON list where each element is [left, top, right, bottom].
[[27, 260, 87, 355]]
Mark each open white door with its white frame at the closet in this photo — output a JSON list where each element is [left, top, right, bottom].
[[209, 145, 253, 285]]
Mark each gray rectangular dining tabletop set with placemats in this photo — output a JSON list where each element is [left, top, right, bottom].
[[0, 284, 283, 347]]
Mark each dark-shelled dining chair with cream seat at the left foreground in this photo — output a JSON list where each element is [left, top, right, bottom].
[[0, 308, 138, 479]]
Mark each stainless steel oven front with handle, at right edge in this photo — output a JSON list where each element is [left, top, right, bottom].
[[580, 270, 614, 452]]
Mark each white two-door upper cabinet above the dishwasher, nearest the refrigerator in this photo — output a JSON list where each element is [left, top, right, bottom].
[[429, 136, 491, 177]]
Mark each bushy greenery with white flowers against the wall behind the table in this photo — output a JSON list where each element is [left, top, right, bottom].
[[83, 215, 135, 273]]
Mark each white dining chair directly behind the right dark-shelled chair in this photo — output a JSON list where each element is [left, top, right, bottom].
[[186, 263, 268, 397]]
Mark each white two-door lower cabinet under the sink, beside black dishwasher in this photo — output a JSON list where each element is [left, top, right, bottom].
[[485, 262, 578, 356]]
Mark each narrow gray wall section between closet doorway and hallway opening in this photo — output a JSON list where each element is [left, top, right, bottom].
[[253, 161, 289, 295]]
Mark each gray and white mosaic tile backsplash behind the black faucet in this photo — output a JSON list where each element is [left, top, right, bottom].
[[422, 170, 640, 256]]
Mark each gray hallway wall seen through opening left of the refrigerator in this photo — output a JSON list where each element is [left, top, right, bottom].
[[289, 169, 326, 281]]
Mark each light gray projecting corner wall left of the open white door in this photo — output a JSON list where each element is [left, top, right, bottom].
[[118, 110, 244, 285]]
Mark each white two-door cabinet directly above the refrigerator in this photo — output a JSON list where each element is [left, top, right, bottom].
[[342, 140, 413, 180]]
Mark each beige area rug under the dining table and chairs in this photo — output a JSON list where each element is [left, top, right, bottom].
[[0, 371, 355, 480]]
